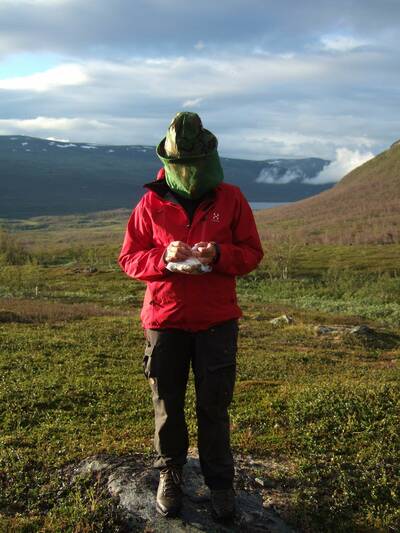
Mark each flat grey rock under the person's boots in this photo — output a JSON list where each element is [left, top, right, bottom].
[[72, 454, 293, 533]]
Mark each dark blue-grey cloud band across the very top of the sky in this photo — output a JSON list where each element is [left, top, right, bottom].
[[0, 0, 400, 57]]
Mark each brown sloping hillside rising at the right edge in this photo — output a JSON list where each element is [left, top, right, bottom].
[[257, 139, 400, 244]]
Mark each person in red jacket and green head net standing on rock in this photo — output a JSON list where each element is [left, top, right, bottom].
[[119, 112, 263, 519]]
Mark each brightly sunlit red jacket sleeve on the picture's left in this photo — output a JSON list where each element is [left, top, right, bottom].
[[118, 196, 169, 281]]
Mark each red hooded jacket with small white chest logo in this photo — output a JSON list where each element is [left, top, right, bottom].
[[119, 172, 263, 331]]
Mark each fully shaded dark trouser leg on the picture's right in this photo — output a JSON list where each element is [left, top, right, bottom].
[[192, 320, 238, 489]]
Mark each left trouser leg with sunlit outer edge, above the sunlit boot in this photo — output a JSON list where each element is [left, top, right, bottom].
[[143, 329, 193, 468]]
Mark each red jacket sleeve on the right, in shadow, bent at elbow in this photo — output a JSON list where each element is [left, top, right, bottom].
[[213, 191, 264, 276]]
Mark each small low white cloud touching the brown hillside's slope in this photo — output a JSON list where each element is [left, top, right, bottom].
[[304, 148, 375, 185]]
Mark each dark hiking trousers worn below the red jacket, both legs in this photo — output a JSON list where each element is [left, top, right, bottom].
[[143, 320, 238, 489]]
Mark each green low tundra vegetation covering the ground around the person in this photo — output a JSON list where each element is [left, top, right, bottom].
[[0, 218, 400, 532]]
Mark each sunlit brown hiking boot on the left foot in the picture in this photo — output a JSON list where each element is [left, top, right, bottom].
[[156, 465, 182, 516]]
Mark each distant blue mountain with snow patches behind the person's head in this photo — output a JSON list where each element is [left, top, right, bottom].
[[0, 135, 333, 218]]
